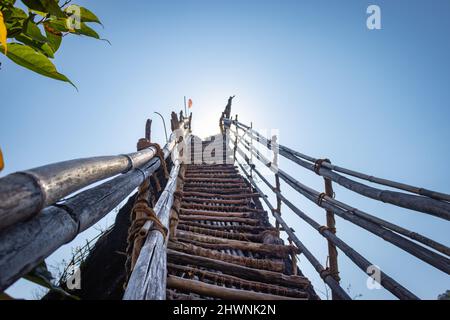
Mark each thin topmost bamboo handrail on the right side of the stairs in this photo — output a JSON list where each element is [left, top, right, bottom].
[[227, 120, 450, 201]]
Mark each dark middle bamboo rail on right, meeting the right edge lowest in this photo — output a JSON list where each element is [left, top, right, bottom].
[[238, 142, 450, 274]]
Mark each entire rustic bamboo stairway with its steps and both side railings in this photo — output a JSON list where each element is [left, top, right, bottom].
[[0, 97, 450, 300]]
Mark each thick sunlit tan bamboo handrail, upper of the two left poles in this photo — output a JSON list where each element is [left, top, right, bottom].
[[0, 119, 185, 230]]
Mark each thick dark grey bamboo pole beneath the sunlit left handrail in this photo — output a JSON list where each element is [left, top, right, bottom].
[[0, 159, 159, 290]]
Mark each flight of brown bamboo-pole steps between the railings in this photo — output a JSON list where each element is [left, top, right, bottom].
[[167, 164, 315, 300]]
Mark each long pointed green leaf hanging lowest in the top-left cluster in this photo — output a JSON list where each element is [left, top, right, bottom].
[[0, 43, 76, 88]]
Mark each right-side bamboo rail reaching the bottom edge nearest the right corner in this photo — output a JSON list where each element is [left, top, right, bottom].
[[237, 155, 418, 300]]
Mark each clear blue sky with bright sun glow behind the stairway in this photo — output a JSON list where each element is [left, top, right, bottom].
[[0, 0, 450, 299]]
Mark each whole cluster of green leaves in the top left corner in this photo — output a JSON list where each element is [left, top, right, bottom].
[[0, 0, 107, 88]]
